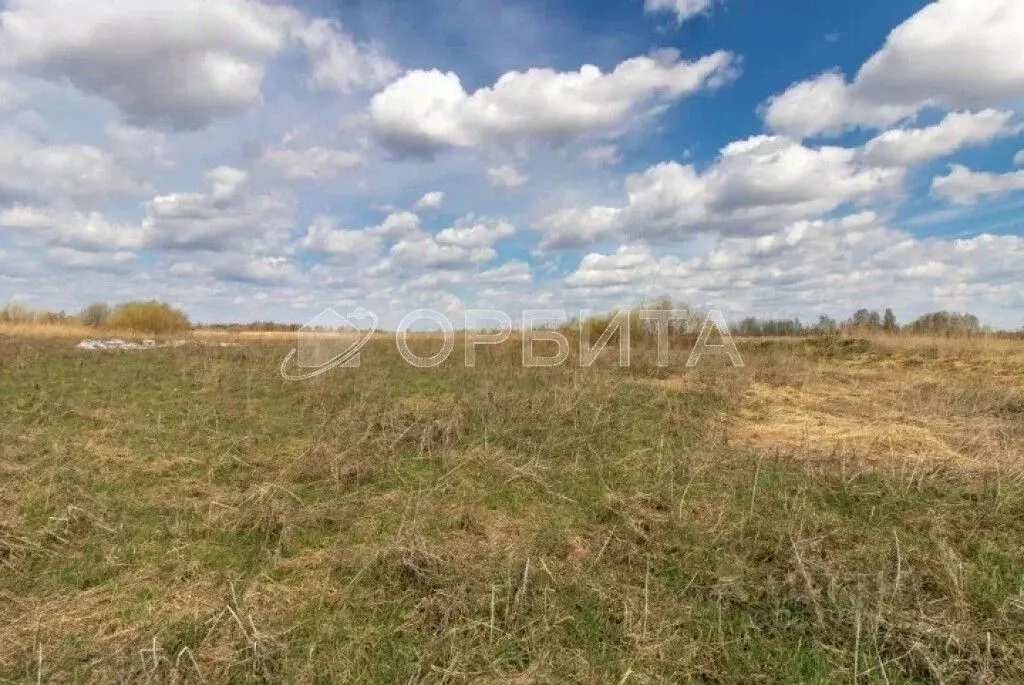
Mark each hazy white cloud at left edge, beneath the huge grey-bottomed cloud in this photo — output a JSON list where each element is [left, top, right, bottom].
[[0, 131, 145, 200]]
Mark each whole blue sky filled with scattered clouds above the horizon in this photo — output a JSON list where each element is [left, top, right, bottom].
[[0, 0, 1024, 329]]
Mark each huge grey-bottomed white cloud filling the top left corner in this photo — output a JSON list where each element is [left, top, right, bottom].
[[0, 0, 395, 129]]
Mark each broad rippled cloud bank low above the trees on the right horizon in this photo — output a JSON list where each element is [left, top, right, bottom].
[[564, 212, 1024, 325]]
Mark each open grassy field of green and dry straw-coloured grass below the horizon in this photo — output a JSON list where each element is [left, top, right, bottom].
[[0, 332, 1024, 684]]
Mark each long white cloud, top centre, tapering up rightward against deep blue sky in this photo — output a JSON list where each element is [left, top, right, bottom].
[[371, 50, 736, 156]]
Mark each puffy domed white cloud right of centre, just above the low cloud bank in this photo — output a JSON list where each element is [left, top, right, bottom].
[[538, 136, 904, 249]]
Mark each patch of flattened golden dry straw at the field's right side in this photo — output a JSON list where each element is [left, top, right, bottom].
[[662, 338, 1024, 470]]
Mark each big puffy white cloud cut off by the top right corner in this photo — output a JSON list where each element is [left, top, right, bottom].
[[764, 0, 1024, 136]]
